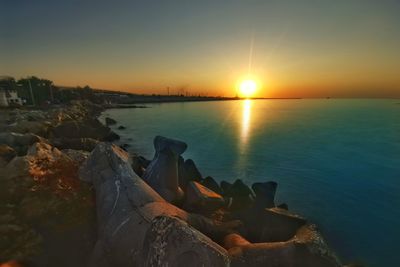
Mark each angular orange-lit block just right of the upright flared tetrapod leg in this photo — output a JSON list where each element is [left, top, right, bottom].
[[184, 181, 225, 214]]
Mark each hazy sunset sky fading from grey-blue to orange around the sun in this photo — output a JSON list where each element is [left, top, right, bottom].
[[0, 0, 400, 97]]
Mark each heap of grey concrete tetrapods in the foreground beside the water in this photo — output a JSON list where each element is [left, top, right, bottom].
[[80, 136, 341, 267]]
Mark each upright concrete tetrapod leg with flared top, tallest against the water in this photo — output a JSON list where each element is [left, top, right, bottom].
[[143, 136, 187, 202]]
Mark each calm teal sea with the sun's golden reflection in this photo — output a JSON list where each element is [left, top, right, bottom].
[[101, 100, 400, 266]]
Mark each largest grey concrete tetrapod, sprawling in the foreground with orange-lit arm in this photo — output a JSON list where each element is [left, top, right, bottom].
[[80, 143, 239, 266]]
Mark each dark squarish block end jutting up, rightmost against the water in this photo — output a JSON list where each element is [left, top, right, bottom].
[[251, 182, 278, 209]]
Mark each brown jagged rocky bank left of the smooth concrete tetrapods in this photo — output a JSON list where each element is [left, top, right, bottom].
[[0, 101, 122, 266]]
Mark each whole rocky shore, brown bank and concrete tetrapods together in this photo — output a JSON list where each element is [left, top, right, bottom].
[[0, 102, 341, 266]]
